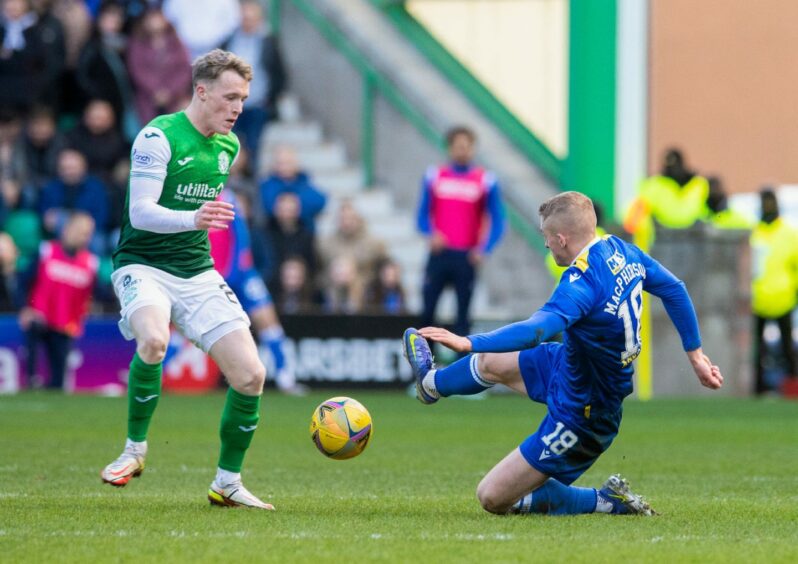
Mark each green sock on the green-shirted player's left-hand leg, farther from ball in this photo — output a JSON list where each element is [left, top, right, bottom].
[[127, 353, 161, 442]]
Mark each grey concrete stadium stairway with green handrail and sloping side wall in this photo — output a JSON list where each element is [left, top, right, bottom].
[[266, 0, 557, 320]]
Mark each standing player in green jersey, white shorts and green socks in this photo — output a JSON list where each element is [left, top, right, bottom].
[[101, 49, 273, 509]]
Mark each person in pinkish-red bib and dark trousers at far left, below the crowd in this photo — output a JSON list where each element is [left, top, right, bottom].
[[19, 212, 99, 389]]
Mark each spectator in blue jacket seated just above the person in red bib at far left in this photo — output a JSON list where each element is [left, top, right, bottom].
[[39, 149, 109, 255]]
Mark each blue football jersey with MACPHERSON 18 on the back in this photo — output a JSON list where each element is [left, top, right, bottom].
[[541, 235, 700, 410]]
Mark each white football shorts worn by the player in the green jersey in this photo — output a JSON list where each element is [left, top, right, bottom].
[[111, 264, 249, 353]]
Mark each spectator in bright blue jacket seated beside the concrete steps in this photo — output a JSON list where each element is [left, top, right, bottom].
[[260, 147, 327, 233]]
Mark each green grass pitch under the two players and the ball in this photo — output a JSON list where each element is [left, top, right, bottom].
[[0, 391, 798, 563]]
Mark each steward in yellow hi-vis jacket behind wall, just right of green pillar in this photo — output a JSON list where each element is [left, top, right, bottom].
[[623, 149, 709, 245]]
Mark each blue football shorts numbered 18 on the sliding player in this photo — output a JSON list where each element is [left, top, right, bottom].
[[518, 343, 623, 485]]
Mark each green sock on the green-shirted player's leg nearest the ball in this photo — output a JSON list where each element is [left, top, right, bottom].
[[219, 388, 260, 472]]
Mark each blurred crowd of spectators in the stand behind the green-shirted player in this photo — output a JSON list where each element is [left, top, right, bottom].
[[0, 0, 406, 326]]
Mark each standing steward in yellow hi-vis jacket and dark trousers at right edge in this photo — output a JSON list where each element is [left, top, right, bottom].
[[751, 189, 798, 394]]
